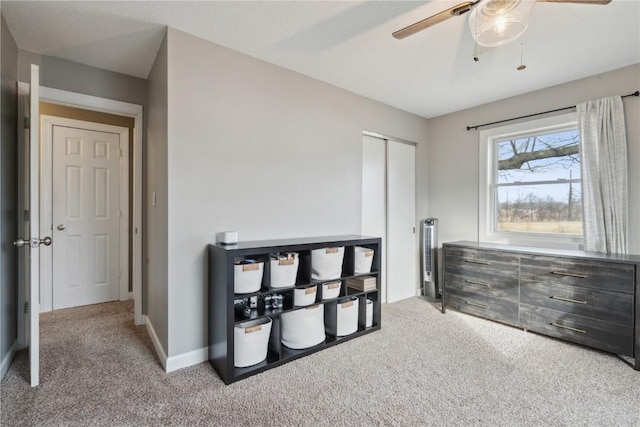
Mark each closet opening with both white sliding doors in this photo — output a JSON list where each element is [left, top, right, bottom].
[[362, 132, 418, 302]]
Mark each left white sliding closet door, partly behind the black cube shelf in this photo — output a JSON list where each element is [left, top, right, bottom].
[[362, 135, 387, 302]]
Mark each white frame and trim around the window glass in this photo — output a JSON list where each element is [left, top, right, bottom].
[[478, 112, 583, 249]]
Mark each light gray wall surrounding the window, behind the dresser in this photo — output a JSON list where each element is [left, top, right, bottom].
[[428, 65, 640, 254]]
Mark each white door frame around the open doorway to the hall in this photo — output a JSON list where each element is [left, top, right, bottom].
[[19, 82, 145, 325]]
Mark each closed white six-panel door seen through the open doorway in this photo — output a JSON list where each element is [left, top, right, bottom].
[[53, 126, 120, 310]]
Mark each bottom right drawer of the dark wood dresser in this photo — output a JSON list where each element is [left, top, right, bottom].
[[520, 304, 633, 356]]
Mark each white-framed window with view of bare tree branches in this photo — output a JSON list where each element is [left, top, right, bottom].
[[479, 113, 582, 249]]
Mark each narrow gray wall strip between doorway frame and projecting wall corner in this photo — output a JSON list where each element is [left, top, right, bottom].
[[143, 35, 169, 353]]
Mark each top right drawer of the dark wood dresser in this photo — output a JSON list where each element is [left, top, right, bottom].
[[520, 255, 635, 295]]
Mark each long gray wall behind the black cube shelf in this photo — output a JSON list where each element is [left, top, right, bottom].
[[158, 28, 427, 357]]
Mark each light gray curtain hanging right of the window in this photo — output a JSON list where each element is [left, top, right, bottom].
[[577, 96, 628, 254]]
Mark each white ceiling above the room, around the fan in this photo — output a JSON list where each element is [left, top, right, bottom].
[[1, 0, 640, 118]]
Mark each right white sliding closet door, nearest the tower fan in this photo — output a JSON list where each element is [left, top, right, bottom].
[[387, 141, 418, 302]]
